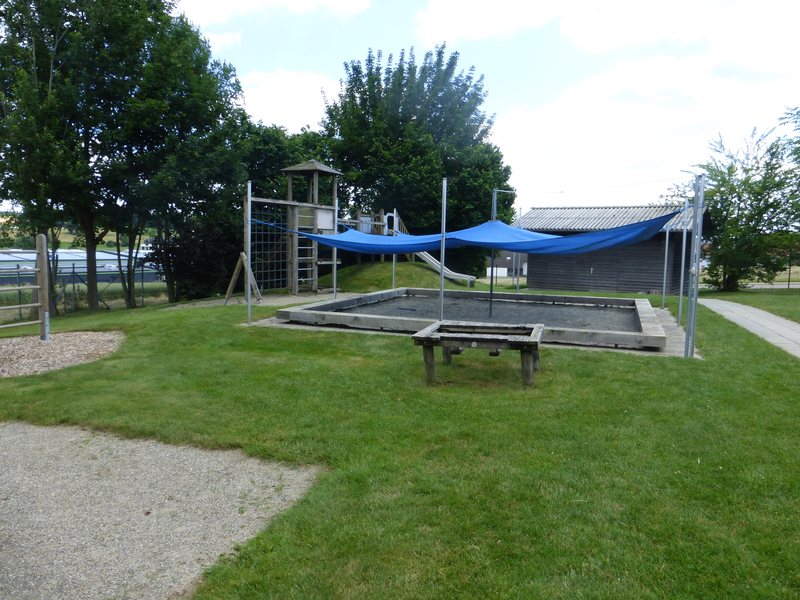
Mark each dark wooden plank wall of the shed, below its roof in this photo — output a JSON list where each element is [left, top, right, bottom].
[[528, 233, 690, 295]]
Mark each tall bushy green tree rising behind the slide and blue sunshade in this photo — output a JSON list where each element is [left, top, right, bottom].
[[323, 45, 513, 272]]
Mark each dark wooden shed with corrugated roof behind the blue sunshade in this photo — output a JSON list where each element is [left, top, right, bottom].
[[514, 205, 704, 295]]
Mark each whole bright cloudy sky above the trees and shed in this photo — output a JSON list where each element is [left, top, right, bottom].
[[178, 0, 800, 209]]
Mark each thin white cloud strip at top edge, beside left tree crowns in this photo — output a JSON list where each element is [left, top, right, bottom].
[[176, 0, 370, 27]]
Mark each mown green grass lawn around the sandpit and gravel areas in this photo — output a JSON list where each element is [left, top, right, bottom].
[[0, 264, 800, 599]]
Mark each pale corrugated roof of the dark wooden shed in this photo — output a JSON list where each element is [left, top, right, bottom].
[[514, 205, 693, 233]]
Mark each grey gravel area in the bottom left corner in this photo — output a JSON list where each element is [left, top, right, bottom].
[[0, 422, 319, 600]]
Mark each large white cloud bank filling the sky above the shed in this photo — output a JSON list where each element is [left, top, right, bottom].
[[416, 0, 800, 207]]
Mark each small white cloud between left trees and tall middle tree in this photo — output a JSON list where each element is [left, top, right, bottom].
[[241, 69, 339, 133]]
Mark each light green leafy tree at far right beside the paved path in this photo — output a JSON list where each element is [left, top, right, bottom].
[[700, 131, 800, 292]]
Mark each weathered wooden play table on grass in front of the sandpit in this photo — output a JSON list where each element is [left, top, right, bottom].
[[411, 321, 544, 385]]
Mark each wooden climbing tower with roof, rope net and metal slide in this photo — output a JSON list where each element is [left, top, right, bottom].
[[244, 160, 475, 299]]
